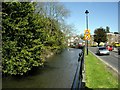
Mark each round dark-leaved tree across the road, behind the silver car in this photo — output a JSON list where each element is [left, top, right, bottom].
[[94, 28, 107, 46]]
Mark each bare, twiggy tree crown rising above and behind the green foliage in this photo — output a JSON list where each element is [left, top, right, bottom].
[[36, 2, 70, 22]]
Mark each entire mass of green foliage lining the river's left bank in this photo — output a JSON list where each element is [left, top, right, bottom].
[[2, 2, 65, 75]]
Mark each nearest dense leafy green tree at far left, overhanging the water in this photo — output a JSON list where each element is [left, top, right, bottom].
[[2, 2, 45, 75]]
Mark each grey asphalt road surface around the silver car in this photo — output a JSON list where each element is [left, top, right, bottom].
[[89, 47, 120, 72]]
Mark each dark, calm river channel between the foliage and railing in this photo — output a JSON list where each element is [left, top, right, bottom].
[[2, 48, 81, 88]]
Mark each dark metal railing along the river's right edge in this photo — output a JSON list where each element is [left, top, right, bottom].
[[71, 47, 84, 90]]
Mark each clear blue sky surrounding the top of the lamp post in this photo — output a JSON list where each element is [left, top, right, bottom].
[[61, 2, 118, 35]]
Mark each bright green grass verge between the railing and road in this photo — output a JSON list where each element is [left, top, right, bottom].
[[85, 52, 118, 88]]
